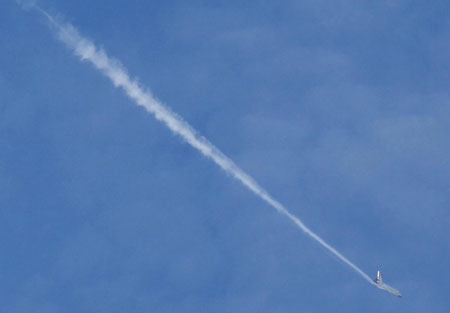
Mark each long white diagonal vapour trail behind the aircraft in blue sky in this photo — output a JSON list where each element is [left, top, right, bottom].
[[35, 7, 373, 284]]
